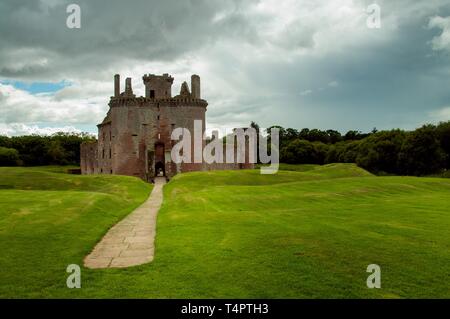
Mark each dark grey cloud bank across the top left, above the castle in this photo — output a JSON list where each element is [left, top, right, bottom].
[[0, 0, 258, 78]]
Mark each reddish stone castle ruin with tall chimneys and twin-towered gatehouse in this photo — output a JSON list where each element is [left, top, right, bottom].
[[80, 73, 253, 181]]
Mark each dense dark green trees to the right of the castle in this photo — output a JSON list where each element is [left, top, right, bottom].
[[268, 122, 450, 175]]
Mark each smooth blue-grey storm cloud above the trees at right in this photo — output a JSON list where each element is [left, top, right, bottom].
[[294, 4, 450, 130]]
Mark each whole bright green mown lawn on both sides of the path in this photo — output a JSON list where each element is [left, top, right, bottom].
[[0, 164, 450, 298]]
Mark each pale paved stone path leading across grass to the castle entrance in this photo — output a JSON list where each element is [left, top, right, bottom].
[[84, 177, 166, 268]]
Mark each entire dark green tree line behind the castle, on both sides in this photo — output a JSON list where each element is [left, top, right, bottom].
[[0, 121, 450, 176]]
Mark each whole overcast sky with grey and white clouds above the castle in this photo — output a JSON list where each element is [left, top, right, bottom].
[[0, 0, 450, 135]]
